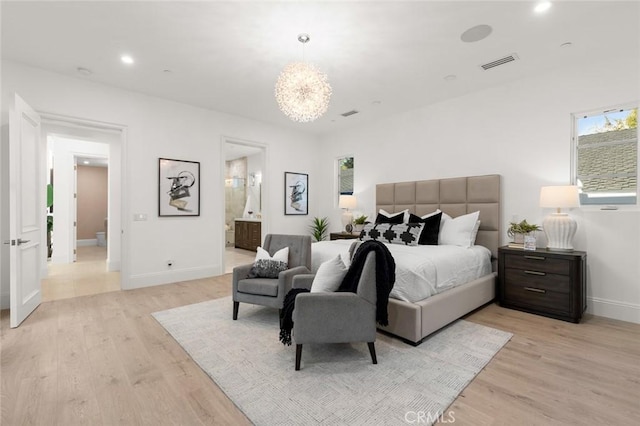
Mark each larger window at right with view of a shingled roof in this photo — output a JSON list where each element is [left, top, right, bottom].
[[572, 106, 638, 204]]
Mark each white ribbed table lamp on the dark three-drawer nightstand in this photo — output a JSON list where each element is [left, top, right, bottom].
[[540, 185, 580, 251]]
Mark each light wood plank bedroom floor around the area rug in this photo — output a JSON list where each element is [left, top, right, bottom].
[[0, 274, 640, 425]]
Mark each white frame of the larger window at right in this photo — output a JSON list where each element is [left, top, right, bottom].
[[570, 103, 640, 207]]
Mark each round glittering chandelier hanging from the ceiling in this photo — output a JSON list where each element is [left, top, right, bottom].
[[275, 34, 331, 123]]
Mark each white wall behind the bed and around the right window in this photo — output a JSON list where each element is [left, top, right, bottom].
[[317, 57, 640, 323]]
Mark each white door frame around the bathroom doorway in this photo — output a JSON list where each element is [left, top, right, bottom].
[[218, 135, 271, 275]]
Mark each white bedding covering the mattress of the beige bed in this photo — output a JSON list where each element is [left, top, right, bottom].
[[311, 240, 491, 302]]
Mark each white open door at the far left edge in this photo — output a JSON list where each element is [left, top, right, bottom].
[[9, 95, 45, 328]]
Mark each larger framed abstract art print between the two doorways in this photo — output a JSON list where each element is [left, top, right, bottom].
[[158, 158, 200, 216]]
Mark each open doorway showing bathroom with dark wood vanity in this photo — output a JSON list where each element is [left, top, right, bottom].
[[223, 139, 266, 273]]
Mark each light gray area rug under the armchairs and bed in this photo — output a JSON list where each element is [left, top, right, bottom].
[[153, 297, 512, 425]]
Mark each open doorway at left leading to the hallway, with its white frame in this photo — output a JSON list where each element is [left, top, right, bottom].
[[41, 116, 123, 301]]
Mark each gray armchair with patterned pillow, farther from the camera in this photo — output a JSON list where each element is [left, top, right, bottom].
[[233, 234, 311, 320]]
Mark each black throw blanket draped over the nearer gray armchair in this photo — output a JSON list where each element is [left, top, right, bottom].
[[280, 241, 396, 345]]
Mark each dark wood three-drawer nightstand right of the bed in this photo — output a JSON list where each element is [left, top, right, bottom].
[[498, 247, 587, 323]]
